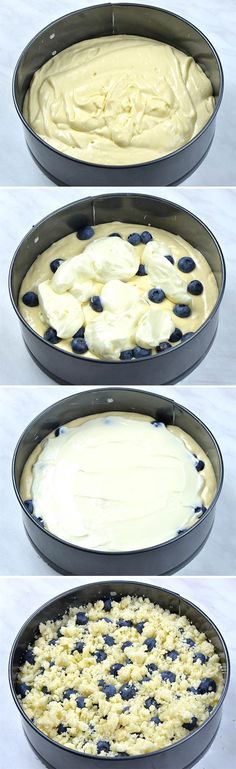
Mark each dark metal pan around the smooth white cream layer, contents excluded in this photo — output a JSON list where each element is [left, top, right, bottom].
[[13, 388, 223, 575]]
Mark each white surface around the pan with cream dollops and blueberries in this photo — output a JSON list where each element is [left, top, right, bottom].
[[0, 187, 236, 384]]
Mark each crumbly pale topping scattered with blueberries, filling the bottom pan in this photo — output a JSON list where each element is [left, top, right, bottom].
[[16, 594, 223, 763]]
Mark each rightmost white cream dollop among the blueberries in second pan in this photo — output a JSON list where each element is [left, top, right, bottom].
[[143, 240, 191, 305]]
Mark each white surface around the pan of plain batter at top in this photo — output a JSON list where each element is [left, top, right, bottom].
[[0, 0, 236, 186]]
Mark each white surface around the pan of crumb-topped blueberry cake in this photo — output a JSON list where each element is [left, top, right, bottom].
[[0, 577, 236, 769]]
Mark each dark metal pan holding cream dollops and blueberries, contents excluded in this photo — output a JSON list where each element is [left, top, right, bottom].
[[9, 193, 225, 385]]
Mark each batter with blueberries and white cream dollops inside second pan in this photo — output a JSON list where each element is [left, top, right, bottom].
[[19, 222, 218, 361]]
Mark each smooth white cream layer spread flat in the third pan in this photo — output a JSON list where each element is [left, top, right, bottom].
[[32, 414, 204, 551]]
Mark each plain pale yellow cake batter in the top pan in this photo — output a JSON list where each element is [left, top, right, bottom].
[[23, 35, 215, 165]]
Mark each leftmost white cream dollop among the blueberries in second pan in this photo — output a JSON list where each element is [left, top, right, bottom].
[[38, 280, 84, 339]]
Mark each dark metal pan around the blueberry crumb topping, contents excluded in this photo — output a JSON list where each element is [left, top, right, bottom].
[[9, 577, 230, 769]]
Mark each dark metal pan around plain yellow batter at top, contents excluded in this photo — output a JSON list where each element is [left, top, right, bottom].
[[13, 3, 223, 187]]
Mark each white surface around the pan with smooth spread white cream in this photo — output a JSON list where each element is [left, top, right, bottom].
[[0, 386, 236, 575]]
